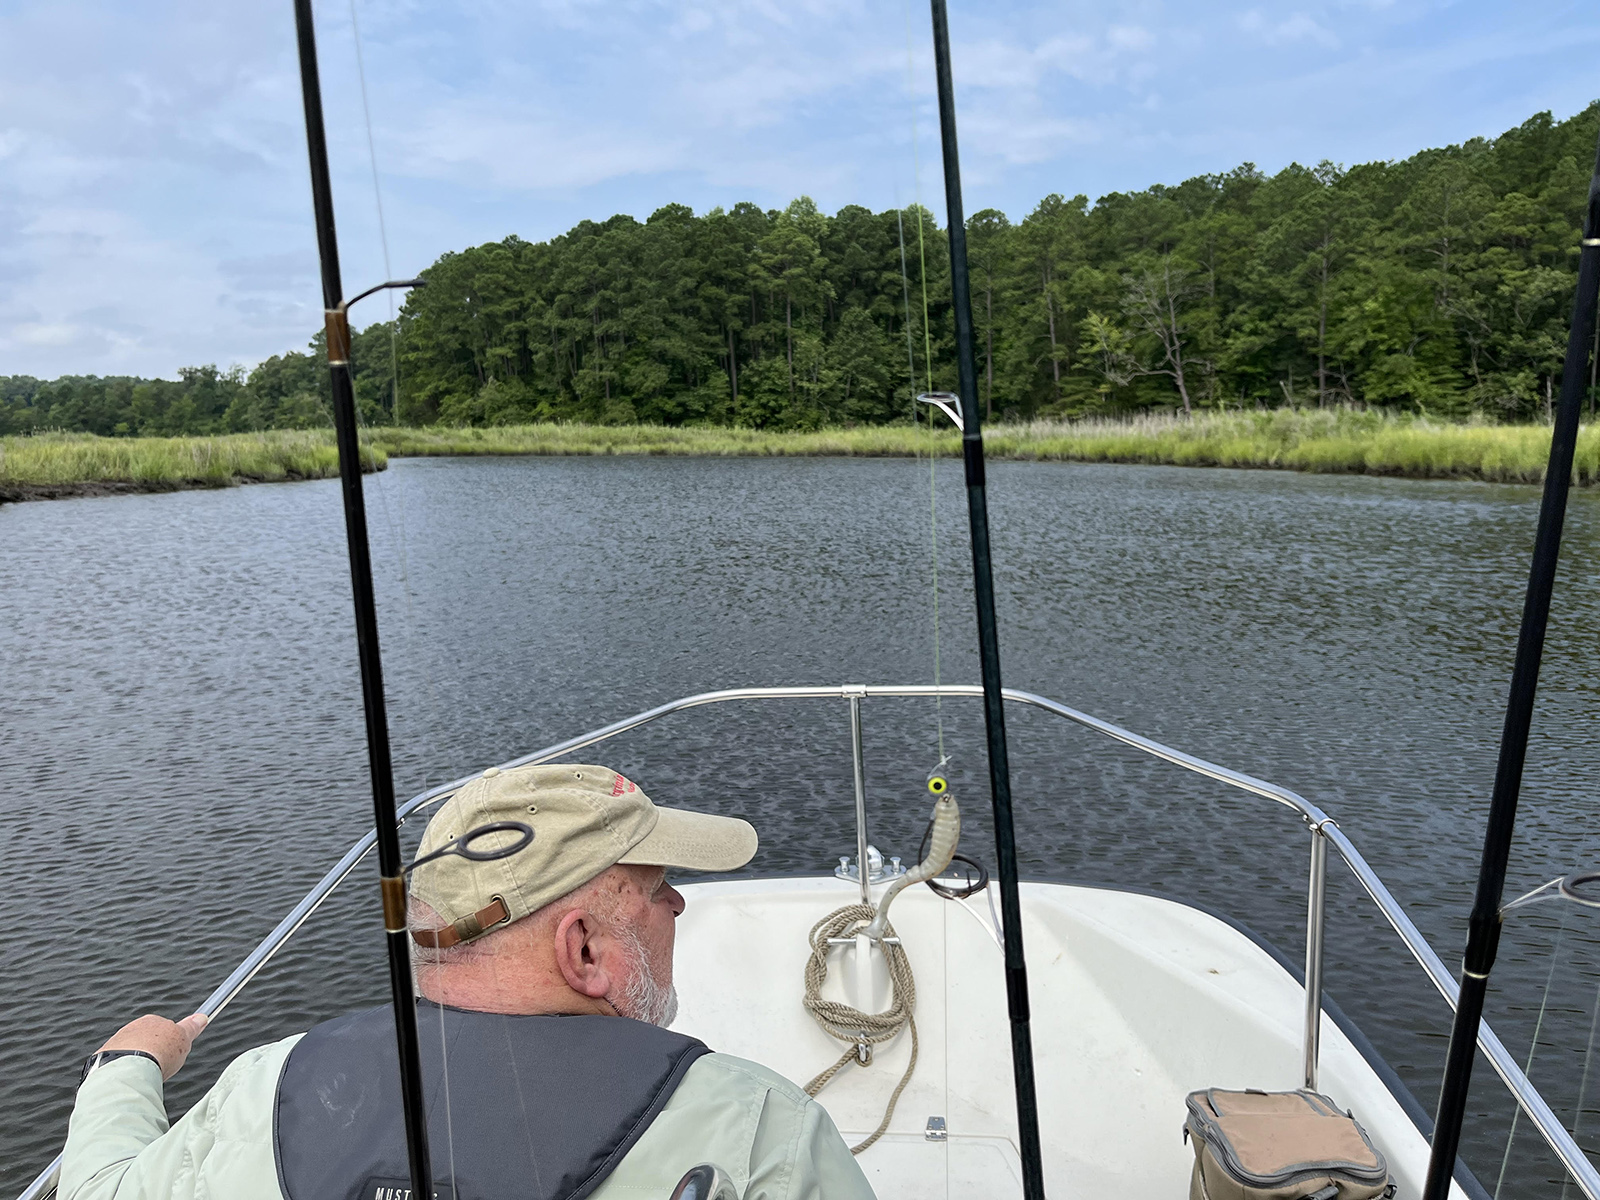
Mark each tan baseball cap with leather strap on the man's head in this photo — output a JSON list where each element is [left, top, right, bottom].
[[411, 763, 757, 947]]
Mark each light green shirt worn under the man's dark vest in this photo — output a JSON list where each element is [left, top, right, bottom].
[[58, 1034, 874, 1200]]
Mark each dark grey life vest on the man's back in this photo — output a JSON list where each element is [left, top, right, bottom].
[[272, 1002, 710, 1200]]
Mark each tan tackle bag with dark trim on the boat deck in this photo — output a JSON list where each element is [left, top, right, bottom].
[[1184, 1088, 1394, 1200]]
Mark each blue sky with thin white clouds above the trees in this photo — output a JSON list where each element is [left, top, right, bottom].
[[0, 0, 1600, 378]]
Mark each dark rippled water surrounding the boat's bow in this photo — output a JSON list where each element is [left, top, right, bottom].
[[0, 459, 1600, 1195]]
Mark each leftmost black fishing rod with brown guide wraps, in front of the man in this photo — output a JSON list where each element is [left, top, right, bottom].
[[294, 0, 434, 1197]]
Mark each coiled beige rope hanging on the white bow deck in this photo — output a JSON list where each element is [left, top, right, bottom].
[[805, 904, 917, 1154]]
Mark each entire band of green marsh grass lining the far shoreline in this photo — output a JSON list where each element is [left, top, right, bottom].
[[0, 408, 1600, 499]]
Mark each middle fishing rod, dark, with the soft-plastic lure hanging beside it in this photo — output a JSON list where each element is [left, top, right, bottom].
[[930, 0, 1045, 1200]]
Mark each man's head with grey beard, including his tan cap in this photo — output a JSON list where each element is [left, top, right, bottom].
[[411, 765, 757, 1024]]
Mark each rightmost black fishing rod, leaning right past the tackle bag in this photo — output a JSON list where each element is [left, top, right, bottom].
[[1422, 122, 1600, 1200]]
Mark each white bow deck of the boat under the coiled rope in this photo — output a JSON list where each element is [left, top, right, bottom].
[[674, 878, 1462, 1200]]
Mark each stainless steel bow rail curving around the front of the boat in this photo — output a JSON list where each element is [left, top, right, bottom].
[[18, 683, 1600, 1200]]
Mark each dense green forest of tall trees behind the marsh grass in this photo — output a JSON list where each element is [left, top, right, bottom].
[[0, 102, 1600, 435]]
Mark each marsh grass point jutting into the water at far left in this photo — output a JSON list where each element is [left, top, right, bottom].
[[0, 429, 387, 496]]
